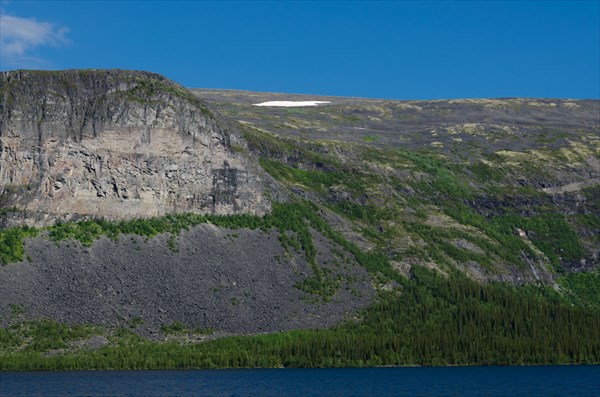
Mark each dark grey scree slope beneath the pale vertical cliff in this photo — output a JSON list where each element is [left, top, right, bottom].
[[0, 225, 373, 334]]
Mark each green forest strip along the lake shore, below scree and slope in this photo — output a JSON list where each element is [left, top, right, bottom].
[[0, 267, 600, 370]]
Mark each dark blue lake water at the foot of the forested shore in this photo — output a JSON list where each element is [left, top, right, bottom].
[[0, 365, 600, 397]]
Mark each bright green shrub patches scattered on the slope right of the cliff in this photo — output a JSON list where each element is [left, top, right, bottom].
[[261, 137, 584, 271]]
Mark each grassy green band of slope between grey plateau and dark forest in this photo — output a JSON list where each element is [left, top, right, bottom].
[[246, 124, 597, 272]]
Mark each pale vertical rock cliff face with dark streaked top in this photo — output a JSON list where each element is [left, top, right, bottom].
[[0, 70, 270, 225]]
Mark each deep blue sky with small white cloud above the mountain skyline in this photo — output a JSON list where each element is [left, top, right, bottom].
[[0, 0, 600, 99]]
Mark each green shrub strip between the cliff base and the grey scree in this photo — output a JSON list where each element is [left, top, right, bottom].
[[0, 201, 390, 299]]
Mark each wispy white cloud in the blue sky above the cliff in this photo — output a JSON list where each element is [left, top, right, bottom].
[[0, 10, 69, 70]]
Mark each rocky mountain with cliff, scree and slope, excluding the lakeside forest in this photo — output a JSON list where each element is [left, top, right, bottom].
[[0, 70, 600, 333]]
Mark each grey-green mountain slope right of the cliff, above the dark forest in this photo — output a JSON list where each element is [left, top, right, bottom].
[[194, 90, 600, 284]]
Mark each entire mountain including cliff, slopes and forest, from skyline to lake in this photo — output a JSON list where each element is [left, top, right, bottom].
[[0, 70, 600, 369]]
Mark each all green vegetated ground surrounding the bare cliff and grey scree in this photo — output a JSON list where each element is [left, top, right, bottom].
[[0, 73, 600, 370]]
